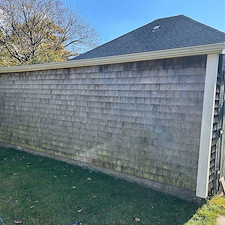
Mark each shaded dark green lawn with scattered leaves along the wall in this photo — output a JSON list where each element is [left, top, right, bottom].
[[0, 148, 198, 225]]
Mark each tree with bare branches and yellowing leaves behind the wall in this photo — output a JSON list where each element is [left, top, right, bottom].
[[0, 0, 97, 66]]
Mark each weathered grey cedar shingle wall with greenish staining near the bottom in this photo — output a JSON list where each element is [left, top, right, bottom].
[[0, 56, 206, 191]]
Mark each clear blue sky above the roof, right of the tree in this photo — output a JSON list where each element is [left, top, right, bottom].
[[62, 0, 225, 43]]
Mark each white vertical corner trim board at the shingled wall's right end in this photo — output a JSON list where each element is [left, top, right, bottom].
[[196, 54, 219, 198]]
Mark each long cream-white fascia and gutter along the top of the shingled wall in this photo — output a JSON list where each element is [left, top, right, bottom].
[[0, 43, 224, 73]]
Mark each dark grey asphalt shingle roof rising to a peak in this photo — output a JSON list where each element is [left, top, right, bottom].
[[74, 15, 225, 59]]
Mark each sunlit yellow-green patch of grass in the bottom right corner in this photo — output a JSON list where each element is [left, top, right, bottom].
[[185, 196, 225, 225]]
